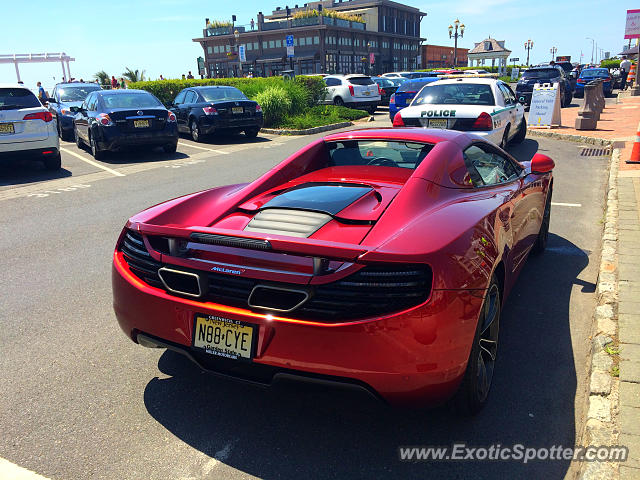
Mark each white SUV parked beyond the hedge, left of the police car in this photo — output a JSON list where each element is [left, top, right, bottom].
[[324, 75, 380, 114]]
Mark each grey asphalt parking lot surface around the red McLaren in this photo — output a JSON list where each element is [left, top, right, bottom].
[[0, 125, 608, 480]]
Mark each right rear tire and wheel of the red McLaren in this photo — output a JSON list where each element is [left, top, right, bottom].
[[452, 275, 501, 416]]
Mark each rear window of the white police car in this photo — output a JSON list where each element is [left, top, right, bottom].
[[412, 82, 495, 105]]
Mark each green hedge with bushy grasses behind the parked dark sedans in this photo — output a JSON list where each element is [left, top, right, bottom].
[[129, 76, 325, 126]]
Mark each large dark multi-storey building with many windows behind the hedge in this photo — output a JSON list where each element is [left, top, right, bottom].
[[193, 0, 426, 77]]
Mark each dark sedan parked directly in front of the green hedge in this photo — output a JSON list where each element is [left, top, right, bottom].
[[169, 86, 264, 142]]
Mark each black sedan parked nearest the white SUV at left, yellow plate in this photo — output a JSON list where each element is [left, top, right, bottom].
[[72, 90, 178, 159]]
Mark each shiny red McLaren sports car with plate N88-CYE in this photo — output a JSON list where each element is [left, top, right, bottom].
[[113, 128, 554, 413]]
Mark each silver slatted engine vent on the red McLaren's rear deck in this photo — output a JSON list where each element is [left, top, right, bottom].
[[245, 208, 332, 238]]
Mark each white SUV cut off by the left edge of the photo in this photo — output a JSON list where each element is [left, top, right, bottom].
[[0, 83, 61, 170]]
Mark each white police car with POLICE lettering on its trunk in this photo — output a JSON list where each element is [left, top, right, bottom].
[[393, 75, 527, 148]]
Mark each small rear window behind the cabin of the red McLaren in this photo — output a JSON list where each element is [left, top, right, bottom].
[[327, 140, 433, 169]]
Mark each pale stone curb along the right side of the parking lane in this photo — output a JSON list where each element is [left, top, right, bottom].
[[579, 148, 620, 480]]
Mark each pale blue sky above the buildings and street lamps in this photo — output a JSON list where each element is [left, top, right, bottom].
[[0, 0, 640, 87]]
